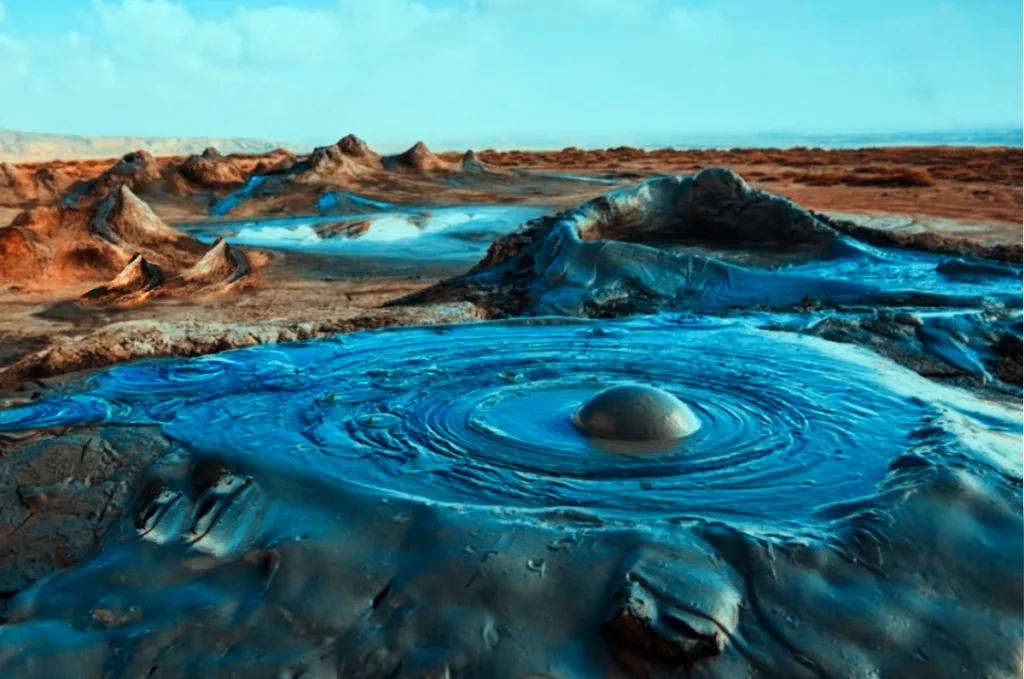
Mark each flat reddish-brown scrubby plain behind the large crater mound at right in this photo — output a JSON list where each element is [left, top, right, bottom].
[[466, 146, 1024, 224]]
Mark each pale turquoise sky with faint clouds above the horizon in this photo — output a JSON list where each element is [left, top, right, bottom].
[[0, 0, 1024, 145]]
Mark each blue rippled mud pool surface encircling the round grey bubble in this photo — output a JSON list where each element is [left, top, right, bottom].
[[0, 316, 1024, 525]]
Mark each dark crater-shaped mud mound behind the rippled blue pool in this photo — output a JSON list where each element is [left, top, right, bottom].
[[395, 168, 1024, 316]]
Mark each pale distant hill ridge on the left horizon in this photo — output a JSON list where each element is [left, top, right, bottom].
[[0, 128, 312, 162]]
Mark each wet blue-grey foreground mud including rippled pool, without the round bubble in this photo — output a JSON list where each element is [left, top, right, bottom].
[[0, 315, 1024, 679]]
